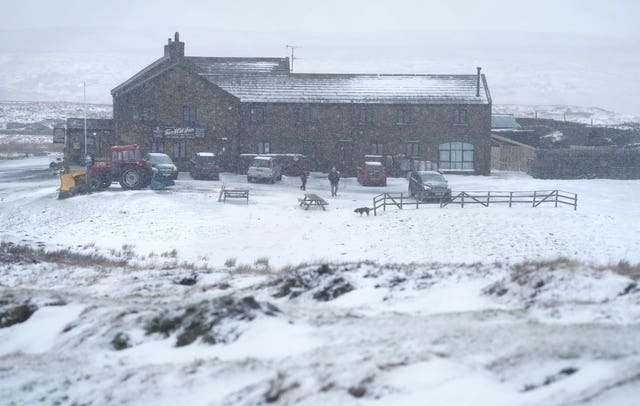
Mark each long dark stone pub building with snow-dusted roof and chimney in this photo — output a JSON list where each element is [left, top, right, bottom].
[[111, 33, 491, 174]]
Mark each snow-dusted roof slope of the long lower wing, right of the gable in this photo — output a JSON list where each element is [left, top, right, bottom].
[[201, 73, 491, 104]]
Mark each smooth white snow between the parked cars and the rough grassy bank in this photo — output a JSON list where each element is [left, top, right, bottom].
[[0, 157, 640, 266]]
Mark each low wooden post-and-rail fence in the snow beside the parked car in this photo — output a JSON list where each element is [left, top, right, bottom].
[[373, 190, 578, 215]]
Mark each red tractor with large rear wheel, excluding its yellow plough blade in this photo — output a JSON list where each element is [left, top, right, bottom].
[[87, 144, 153, 190]]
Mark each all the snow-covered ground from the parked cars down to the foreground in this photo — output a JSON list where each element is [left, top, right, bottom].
[[0, 156, 640, 405]]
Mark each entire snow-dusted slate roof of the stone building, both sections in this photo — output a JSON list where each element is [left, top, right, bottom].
[[112, 53, 491, 104]]
